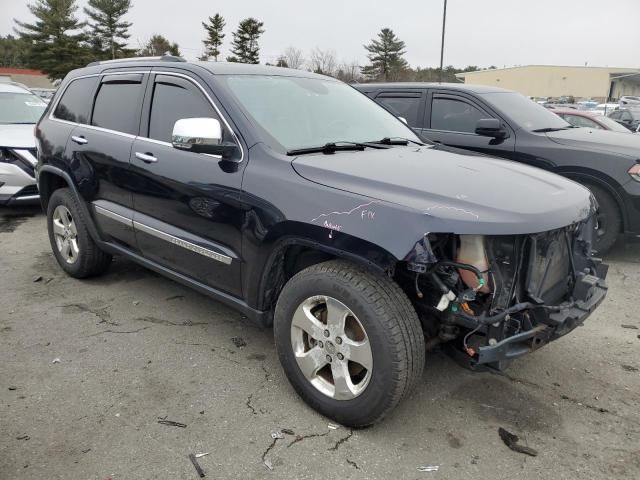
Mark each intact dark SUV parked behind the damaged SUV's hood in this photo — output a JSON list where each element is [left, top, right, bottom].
[[356, 83, 640, 253]]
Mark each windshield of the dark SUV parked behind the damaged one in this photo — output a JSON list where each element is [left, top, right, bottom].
[[481, 92, 571, 131]]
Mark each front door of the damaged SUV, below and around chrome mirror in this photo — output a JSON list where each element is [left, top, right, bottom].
[[132, 73, 246, 296]]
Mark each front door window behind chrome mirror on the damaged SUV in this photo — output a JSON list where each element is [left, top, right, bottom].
[[149, 76, 220, 142]]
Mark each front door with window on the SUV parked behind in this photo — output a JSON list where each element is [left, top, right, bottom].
[[421, 90, 515, 159]]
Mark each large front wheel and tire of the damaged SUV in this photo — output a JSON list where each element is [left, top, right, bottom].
[[274, 260, 425, 428]]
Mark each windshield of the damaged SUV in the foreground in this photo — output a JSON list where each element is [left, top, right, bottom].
[[224, 75, 421, 151]]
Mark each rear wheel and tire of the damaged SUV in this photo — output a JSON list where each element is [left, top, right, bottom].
[[47, 188, 112, 278]]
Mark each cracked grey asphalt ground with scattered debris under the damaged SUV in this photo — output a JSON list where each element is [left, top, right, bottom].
[[0, 209, 640, 480]]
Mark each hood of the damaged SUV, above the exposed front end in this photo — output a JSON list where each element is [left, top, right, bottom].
[[293, 146, 593, 234]]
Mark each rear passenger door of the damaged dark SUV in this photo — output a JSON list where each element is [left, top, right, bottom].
[[69, 71, 148, 250]]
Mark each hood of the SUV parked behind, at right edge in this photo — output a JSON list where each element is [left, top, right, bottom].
[[546, 128, 640, 159]]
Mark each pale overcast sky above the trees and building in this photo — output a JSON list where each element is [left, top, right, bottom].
[[0, 0, 640, 68]]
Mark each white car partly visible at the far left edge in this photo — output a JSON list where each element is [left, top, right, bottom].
[[0, 83, 47, 205]]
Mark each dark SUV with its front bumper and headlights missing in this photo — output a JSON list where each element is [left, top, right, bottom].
[[36, 57, 606, 426]]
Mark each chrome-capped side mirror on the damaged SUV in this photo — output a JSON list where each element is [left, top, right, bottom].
[[171, 118, 238, 159]]
